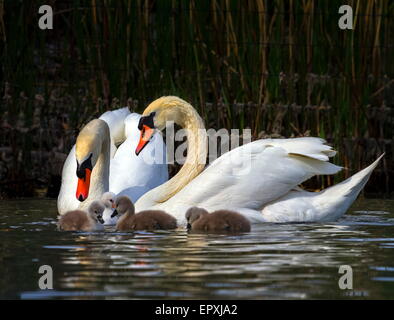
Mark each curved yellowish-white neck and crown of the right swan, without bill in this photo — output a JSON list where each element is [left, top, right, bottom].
[[135, 97, 207, 211]]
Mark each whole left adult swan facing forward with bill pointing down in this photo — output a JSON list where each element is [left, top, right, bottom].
[[57, 108, 168, 220]]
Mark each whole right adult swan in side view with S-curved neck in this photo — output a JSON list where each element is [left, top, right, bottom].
[[135, 96, 382, 225]]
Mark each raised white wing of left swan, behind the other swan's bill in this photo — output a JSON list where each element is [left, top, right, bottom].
[[109, 113, 168, 202]]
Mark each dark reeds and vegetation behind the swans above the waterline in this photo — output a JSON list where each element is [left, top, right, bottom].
[[0, 0, 394, 197]]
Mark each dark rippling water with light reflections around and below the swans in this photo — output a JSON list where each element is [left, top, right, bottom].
[[0, 200, 394, 299]]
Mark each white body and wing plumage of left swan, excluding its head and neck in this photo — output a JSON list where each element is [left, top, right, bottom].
[[57, 108, 168, 222]]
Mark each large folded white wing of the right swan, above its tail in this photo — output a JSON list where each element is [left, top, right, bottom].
[[160, 137, 341, 223]]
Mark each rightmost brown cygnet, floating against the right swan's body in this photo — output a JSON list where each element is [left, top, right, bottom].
[[185, 207, 250, 232]]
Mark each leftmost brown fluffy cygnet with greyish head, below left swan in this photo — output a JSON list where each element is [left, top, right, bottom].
[[58, 201, 105, 231]]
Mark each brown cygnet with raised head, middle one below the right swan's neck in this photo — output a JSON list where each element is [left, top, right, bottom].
[[111, 196, 177, 231]]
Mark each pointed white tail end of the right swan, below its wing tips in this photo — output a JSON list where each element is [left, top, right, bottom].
[[261, 154, 384, 222]]
